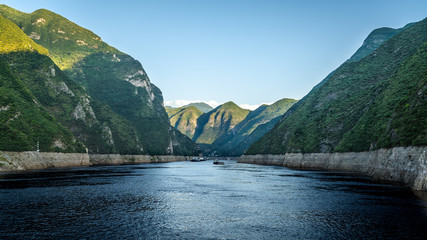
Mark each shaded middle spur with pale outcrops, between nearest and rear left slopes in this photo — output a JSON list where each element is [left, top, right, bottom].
[[0, 52, 143, 153]]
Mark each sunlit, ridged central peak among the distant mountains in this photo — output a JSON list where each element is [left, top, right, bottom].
[[193, 102, 249, 144]]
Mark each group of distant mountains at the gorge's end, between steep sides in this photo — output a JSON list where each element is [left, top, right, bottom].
[[166, 99, 296, 156]]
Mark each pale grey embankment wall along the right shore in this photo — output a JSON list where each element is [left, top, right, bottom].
[[238, 146, 427, 191]]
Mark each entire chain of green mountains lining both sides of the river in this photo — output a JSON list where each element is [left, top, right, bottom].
[[0, 5, 427, 156]]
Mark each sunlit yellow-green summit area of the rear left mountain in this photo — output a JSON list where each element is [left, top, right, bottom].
[[0, 5, 120, 70]]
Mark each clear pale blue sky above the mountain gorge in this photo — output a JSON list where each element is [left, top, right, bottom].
[[0, 0, 427, 109]]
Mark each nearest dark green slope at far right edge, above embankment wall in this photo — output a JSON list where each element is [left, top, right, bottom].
[[337, 42, 427, 151]]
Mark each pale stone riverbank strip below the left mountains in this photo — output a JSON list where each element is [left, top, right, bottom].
[[0, 151, 190, 172]]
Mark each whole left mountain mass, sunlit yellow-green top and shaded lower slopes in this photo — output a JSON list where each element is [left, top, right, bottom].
[[0, 5, 197, 155]]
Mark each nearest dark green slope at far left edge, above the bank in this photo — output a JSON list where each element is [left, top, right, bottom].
[[0, 60, 85, 152]]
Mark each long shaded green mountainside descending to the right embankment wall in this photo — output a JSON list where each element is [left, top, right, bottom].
[[246, 19, 427, 155]]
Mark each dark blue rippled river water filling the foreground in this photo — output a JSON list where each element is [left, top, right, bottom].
[[0, 161, 427, 239]]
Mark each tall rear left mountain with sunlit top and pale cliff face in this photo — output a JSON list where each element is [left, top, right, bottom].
[[0, 5, 195, 157]]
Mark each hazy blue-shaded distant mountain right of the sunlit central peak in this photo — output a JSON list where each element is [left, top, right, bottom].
[[211, 98, 297, 156]]
